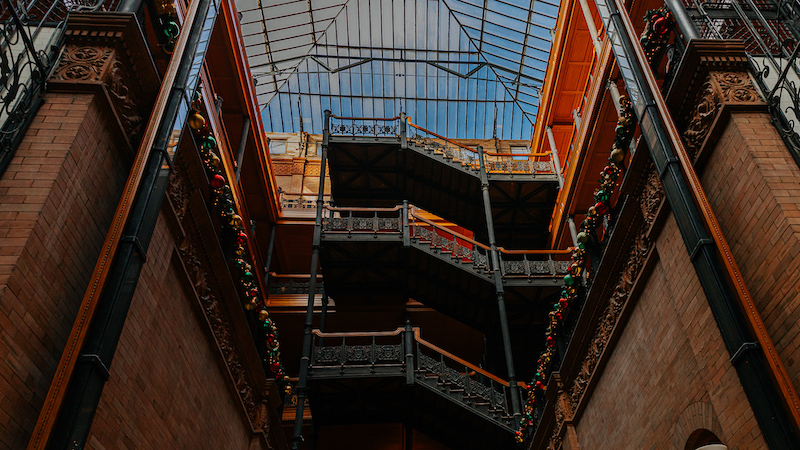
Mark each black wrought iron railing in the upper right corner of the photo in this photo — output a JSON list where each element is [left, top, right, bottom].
[[675, 0, 800, 165]]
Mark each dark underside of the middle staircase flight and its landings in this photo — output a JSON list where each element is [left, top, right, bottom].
[[320, 239, 559, 332]]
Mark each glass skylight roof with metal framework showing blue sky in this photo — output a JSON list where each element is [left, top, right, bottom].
[[237, 0, 558, 139]]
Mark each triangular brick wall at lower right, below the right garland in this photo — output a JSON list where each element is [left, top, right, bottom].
[[577, 216, 766, 450]]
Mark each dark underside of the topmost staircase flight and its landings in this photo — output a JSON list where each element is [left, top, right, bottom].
[[328, 137, 558, 248]]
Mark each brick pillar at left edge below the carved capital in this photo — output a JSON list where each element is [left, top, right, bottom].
[[0, 94, 127, 449]]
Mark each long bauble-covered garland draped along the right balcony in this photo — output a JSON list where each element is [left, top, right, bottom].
[[516, 96, 636, 442]]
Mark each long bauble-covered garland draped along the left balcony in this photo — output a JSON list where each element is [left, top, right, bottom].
[[187, 93, 290, 392]]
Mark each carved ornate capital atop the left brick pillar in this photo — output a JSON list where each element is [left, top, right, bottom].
[[48, 13, 160, 146]]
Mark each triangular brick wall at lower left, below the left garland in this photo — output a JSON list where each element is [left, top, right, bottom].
[[87, 213, 252, 449]]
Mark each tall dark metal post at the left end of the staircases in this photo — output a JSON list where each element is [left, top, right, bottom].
[[292, 109, 331, 450]]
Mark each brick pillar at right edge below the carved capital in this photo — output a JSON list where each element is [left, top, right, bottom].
[[701, 113, 800, 390]]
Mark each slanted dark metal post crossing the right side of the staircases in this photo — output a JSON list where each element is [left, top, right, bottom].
[[478, 145, 522, 420]]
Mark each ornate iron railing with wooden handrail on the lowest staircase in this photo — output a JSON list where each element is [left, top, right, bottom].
[[310, 327, 524, 432]]
